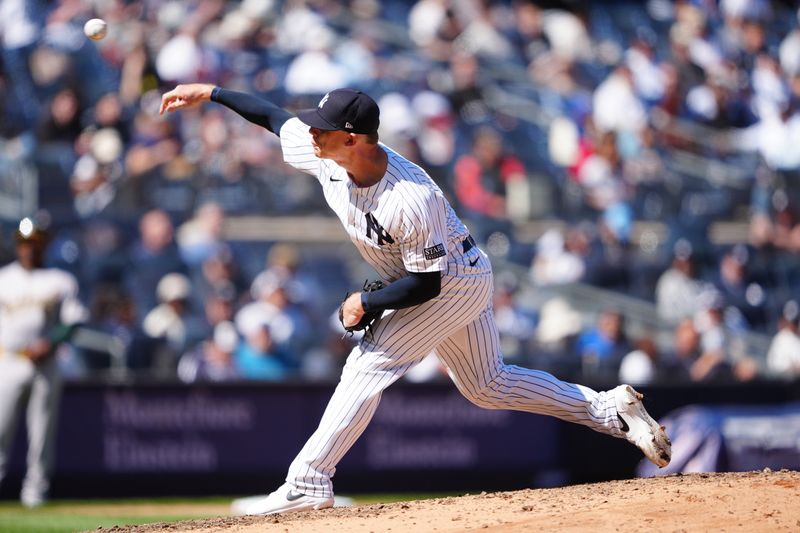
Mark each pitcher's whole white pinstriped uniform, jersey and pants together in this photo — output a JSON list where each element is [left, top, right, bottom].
[[272, 118, 636, 502]]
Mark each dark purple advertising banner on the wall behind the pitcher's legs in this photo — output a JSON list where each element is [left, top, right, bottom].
[[7, 385, 559, 478]]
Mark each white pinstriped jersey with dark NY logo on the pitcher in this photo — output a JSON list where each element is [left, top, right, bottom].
[[280, 118, 469, 281]]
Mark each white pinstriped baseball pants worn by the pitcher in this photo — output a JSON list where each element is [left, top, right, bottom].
[[286, 252, 622, 497]]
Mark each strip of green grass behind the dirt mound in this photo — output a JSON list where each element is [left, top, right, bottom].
[[0, 493, 452, 533]]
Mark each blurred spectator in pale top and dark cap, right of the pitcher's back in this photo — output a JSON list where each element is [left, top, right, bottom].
[[655, 239, 704, 324]]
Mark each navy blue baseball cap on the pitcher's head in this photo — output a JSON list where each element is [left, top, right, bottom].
[[297, 89, 380, 134]]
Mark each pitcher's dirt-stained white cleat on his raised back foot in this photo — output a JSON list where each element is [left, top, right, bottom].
[[614, 385, 672, 468]]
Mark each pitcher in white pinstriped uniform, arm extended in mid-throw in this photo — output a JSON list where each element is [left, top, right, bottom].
[[161, 84, 671, 515]]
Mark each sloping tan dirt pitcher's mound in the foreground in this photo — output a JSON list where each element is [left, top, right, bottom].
[[108, 470, 800, 533]]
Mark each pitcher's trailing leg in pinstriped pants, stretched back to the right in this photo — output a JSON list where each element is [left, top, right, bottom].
[[436, 308, 623, 437]]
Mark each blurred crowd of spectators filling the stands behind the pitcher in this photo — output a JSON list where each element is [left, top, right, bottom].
[[0, 0, 800, 383]]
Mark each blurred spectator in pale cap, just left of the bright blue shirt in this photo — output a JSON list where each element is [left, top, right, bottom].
[[178, 321, 241, 383]]
